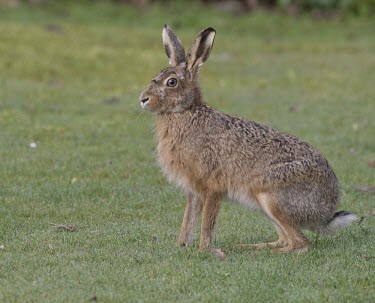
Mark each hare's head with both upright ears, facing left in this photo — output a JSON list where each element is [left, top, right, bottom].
[[139, 25, 215, 114]]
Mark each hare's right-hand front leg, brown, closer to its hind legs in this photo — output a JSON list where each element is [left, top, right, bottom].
[[199, 193, 221, 250]]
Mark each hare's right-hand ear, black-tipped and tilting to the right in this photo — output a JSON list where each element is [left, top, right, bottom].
[[186, 27, 216, 73]]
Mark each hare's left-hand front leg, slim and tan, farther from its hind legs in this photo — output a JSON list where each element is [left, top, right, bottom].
[[178, 193, 203, 246]]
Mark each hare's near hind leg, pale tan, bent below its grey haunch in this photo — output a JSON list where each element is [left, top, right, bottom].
[[258, 193, 309, 252]]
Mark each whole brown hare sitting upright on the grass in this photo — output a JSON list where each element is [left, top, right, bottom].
[[140, 25, 357, 255]]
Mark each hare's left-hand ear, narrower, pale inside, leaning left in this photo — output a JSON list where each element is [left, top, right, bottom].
[[162, 24, 185, 66]]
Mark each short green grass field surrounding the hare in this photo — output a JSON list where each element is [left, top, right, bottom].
[[0, 1, 375, 303]]
